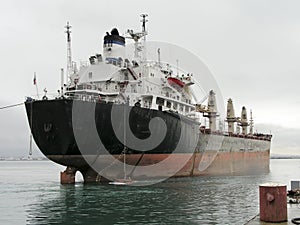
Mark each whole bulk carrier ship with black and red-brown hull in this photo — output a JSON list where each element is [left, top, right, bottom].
[[25, 14, 272, 183]]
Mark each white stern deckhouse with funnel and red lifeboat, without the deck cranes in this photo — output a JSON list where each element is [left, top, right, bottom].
[[65, 15, 195, 118]]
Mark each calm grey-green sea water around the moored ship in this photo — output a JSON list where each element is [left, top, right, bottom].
[[0, 159, 300, 225]]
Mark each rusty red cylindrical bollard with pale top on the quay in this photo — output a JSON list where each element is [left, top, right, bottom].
[[259, 183, 287, 222]]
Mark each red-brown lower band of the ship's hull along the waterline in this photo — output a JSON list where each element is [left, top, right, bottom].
[[49, 151, 269, 182]]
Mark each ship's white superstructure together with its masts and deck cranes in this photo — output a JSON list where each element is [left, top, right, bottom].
[[61, 14, 253, 135]]
